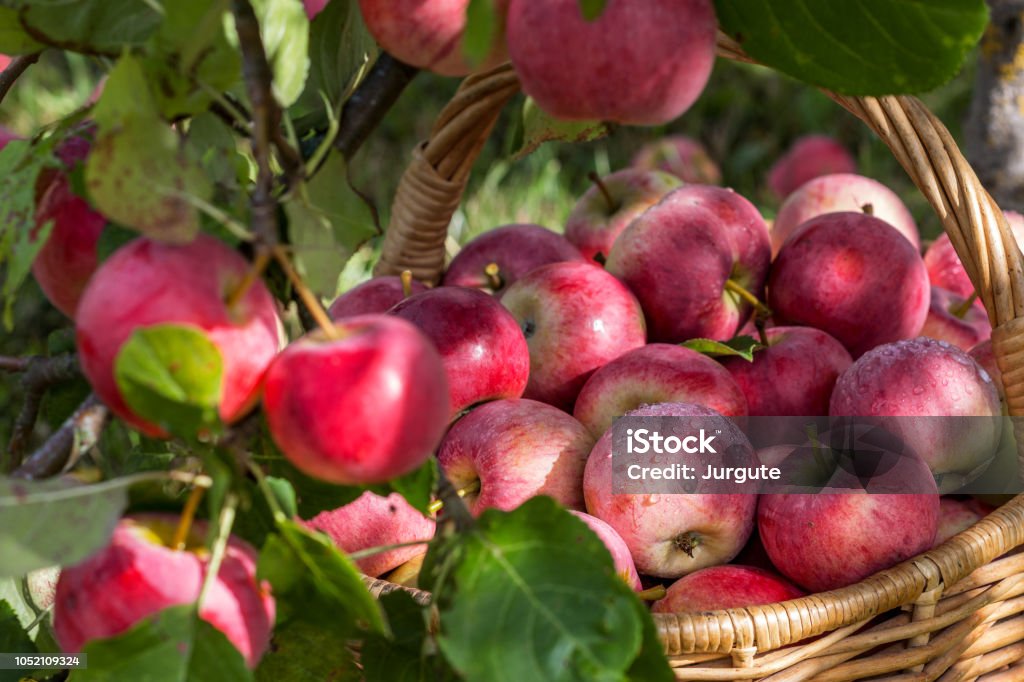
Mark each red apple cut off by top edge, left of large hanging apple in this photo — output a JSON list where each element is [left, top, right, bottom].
[[356, 0, 508, 76]]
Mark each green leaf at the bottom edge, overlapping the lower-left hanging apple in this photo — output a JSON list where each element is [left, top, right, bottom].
[[74, 604, 253, 682]]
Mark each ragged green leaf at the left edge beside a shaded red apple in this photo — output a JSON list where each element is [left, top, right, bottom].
[[0, 136, 55, 330]]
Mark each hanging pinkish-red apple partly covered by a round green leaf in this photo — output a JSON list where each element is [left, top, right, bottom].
[[75, 235, 279, 435]]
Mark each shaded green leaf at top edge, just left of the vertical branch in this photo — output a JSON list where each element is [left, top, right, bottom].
[[145, 0, 242, 119]]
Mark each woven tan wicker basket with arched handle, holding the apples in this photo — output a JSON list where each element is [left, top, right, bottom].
[[366, 34, 1024, 682]]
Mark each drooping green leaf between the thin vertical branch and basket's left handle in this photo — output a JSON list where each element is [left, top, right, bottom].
[[285, 153, 377, 295]]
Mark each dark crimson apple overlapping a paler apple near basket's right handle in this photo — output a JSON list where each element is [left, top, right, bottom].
[[768, 212, 929, 358]]
